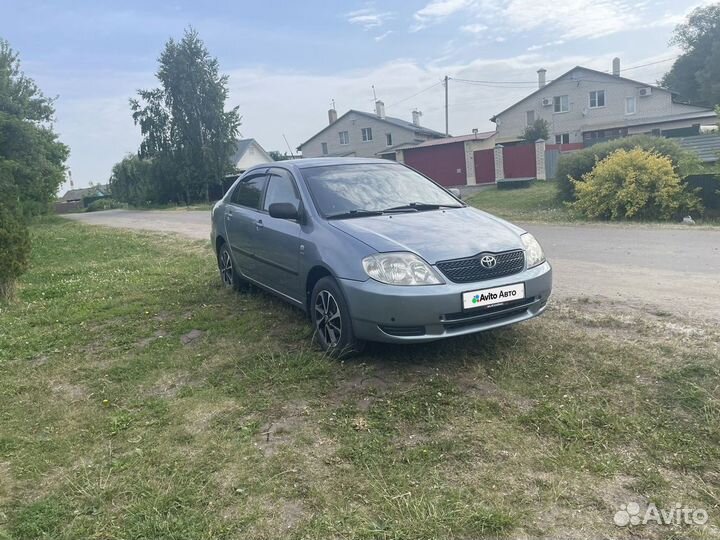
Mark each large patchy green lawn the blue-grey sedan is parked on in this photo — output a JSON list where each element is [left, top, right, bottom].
[[0, 219, 720, 539]]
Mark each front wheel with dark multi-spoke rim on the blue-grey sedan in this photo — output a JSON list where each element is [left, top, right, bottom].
[[310, 277, 365, 358]]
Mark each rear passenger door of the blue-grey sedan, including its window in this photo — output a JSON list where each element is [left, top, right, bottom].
[[225, 169, 267, 280]]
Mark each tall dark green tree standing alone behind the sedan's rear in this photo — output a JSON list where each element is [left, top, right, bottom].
[[130, 29, 240, 203]]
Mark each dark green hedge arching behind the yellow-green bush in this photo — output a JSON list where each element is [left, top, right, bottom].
[[556, 135, 702, 201]]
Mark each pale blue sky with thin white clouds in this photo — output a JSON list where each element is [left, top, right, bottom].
[[0, 0, 709, 192]]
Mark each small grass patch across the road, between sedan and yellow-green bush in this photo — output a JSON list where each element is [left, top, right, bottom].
[[466, 180, 575, 222]]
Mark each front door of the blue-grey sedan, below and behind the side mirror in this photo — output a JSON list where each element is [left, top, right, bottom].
[[256, 168, 303, 303]]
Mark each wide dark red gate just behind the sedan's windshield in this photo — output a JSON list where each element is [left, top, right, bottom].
[[403, 142, 467, 186]]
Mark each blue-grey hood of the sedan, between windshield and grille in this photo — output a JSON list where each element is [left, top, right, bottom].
[[329, 207, 525, 264]]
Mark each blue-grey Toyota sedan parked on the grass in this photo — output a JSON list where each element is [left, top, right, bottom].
[[211, 158, 552, 353]]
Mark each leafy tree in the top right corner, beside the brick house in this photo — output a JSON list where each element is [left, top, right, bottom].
[[660, 3, 720, 106]]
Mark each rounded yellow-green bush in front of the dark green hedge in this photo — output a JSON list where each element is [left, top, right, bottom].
[[571, 148, 701, 220]]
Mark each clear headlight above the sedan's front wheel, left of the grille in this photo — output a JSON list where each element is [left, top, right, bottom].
[[363, 252, 445, 285]]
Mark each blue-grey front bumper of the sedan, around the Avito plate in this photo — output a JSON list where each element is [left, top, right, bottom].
[[340, 262, 552, 343]]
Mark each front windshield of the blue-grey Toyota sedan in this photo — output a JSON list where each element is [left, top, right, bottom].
[[303, 164, 463, 218]]
